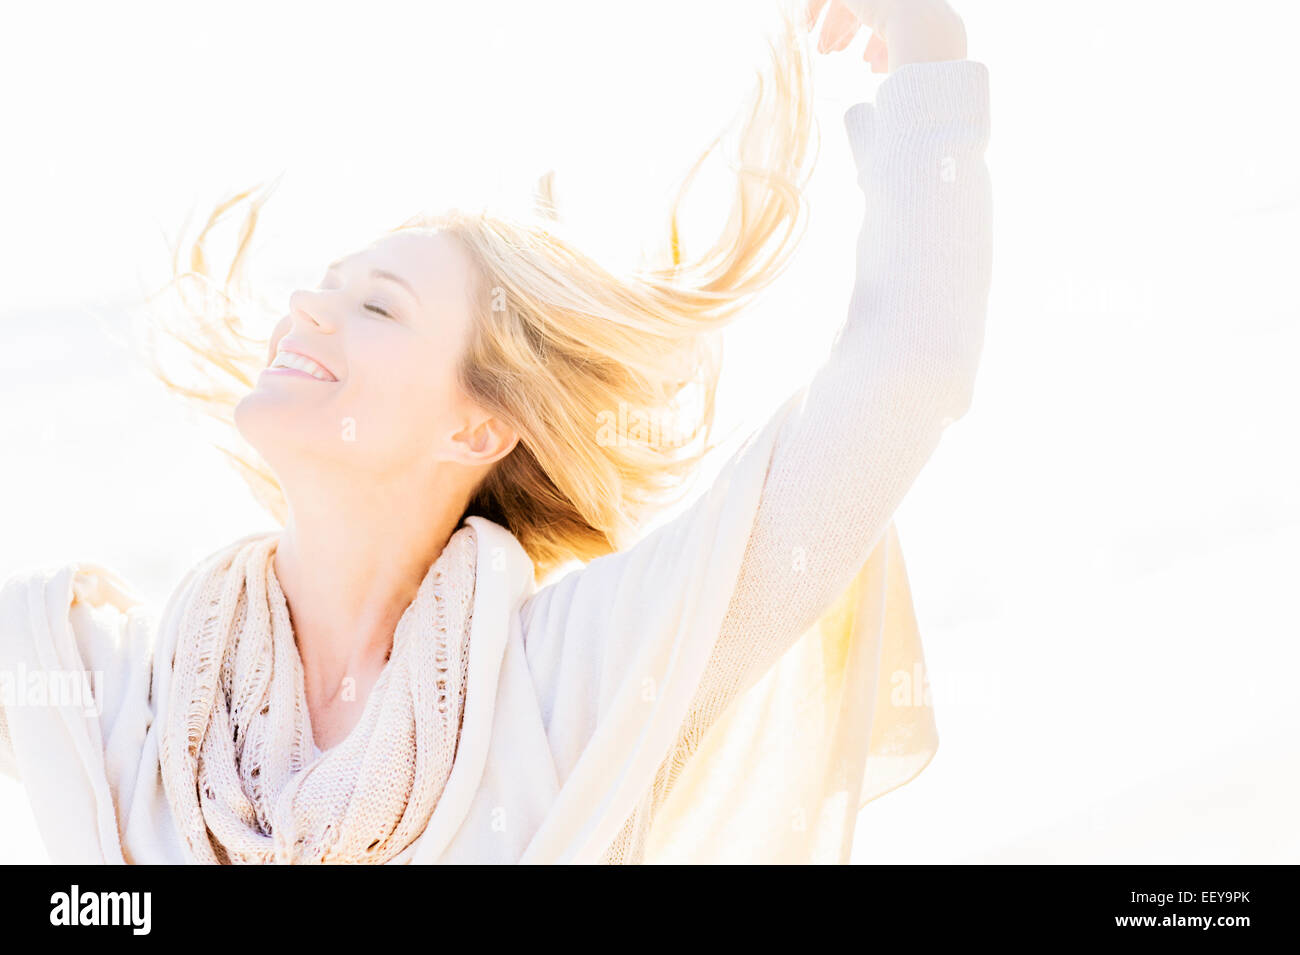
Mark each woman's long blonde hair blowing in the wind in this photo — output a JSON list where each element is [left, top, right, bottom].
[[146, 8, 815, 579]]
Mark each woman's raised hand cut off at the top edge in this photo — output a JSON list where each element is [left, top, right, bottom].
[[803, 0, 966, 73]]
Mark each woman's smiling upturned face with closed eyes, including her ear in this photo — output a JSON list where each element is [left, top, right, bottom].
[[235, 231, 514, 490]]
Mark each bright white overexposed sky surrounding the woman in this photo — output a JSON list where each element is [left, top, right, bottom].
[[0, 0, 1300, 861]]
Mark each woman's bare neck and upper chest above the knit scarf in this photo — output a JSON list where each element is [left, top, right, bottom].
[[274, 465, 468, 699]]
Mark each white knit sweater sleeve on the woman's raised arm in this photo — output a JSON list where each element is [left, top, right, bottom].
[[0, 60, 992, 861]]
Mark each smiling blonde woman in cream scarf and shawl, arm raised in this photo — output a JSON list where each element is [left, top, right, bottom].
[[0, 0, 989, 863]]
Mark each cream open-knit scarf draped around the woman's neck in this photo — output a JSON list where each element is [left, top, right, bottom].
[[160, 525, 476, 864]]
